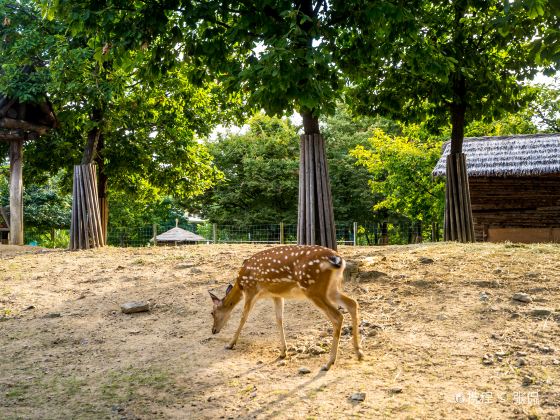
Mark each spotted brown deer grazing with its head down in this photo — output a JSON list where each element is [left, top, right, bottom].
[[209, 245, 363, 370]]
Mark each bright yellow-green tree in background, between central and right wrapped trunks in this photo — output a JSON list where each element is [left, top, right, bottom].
[[351, 126, 445, 221]]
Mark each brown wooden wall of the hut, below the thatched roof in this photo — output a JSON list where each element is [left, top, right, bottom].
[[469, 174, 560, 242]]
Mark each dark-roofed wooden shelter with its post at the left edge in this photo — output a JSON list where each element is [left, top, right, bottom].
[[0, 94, 56, 245]]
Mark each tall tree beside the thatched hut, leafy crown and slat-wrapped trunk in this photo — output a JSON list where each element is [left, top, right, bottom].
[[336, 0, 545, 241]]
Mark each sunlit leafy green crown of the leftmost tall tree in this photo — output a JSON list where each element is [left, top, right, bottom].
[[0, 0, 228, 246]]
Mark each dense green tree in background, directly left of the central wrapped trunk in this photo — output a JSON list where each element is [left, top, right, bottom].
[[195, 114, 299, 225]]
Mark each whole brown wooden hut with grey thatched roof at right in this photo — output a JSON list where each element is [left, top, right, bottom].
[[433, 134, 560, 242]]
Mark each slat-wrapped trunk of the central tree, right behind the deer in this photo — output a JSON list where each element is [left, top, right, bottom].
[[298, 112, 336, 250]]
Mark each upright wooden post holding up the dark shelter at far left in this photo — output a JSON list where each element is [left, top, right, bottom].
[[9, 139, 23, 245]]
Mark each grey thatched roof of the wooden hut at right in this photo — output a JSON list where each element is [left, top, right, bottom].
[[432, 133, 560, 177]]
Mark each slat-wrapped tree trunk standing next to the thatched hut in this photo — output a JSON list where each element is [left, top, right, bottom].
[[444, 104, 474, 242]]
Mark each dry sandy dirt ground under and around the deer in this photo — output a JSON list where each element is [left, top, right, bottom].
[[0, 243, 560, 419]]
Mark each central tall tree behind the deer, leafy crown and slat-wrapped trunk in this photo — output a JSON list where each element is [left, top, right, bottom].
[[44, 0, 376, 248]]
